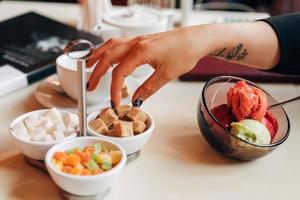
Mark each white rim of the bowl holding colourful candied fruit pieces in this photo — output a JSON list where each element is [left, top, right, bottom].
[[45, 136, 127, 180]]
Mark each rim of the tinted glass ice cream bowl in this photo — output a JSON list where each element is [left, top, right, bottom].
[[201, 76, 290, 147]]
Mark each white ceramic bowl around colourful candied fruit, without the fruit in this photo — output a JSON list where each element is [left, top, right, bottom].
[[45, 137, 127, 196]]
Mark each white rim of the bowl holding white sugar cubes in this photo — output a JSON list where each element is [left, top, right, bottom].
[[8, 108, 76, 146]]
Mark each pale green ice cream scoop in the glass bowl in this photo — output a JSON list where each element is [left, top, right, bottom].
[[231, 119, 271, 144]]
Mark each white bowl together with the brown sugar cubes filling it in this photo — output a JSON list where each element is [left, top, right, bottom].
[[87, 105, 155, 155]]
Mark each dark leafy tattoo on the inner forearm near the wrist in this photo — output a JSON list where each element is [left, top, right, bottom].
[[209, 43, 248, 61]]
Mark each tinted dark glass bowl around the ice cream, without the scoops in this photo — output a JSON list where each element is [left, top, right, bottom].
[[197, 76, 290, 160]]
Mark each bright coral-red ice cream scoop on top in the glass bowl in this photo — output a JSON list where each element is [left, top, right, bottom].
[[227, 81, 268, 121]]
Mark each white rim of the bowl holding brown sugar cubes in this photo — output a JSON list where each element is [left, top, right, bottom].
[[87, 108, 155, 141]]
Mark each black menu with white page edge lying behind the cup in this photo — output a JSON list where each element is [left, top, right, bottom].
[[0, 12, 102, 96]]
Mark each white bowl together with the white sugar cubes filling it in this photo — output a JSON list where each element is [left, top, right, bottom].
[[9, 108, 79, 160]]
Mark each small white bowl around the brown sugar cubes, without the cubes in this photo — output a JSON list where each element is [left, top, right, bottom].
[[87, 111, 155, 155]]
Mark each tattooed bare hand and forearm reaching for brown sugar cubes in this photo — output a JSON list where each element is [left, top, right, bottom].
[[87, 22, 280, 106]]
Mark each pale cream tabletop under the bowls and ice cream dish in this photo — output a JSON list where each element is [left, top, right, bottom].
[[0, 2, 300, 200]]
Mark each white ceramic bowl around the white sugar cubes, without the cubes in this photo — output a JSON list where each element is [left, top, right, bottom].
[[9, 109, 76, 160]]
